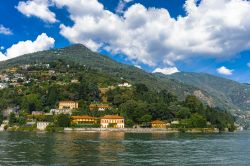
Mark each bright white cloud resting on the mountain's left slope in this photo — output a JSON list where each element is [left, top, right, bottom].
[[0, 33, 55, 61]]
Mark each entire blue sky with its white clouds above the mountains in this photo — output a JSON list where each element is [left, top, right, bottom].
[[0, 0, 250, 83]]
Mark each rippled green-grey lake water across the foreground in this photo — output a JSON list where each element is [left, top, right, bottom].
[[0, 132, 250, 166]]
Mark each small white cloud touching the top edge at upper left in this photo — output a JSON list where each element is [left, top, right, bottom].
[[16, 0, 57, 23]]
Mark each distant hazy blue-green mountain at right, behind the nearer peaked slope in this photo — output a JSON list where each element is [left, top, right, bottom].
[[167, 72, 250, 111]]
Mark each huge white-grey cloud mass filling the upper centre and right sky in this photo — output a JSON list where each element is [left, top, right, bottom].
[[25, 0, 250, 66]]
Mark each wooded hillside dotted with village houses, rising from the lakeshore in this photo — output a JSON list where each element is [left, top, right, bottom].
[[0, 60, 235, 131]]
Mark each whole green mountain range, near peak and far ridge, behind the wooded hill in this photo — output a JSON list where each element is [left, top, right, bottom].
[[0, 44, 250, 110]]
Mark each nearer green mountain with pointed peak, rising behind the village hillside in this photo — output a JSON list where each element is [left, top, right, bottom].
[[0, 44, 200, 96]]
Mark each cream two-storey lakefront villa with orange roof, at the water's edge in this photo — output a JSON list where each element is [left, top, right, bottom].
[[100, 115, 124, 128]]
